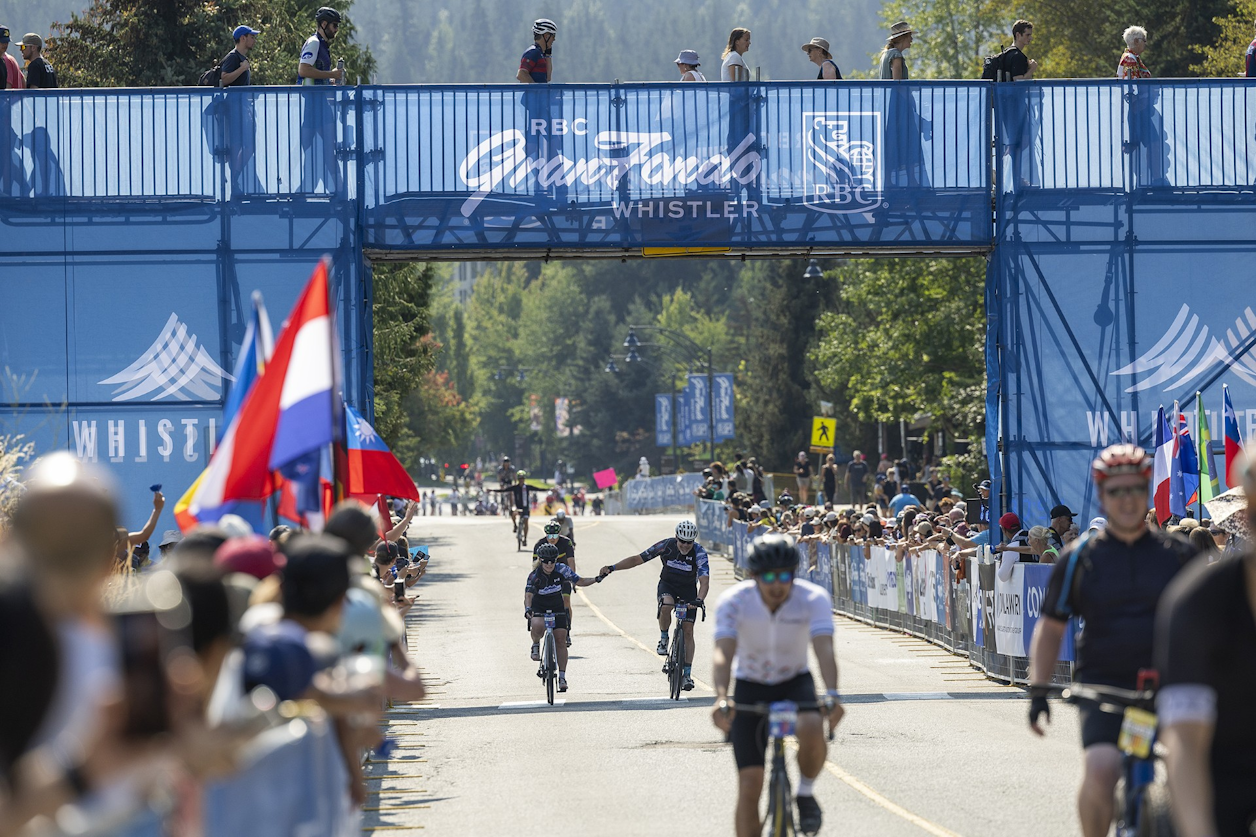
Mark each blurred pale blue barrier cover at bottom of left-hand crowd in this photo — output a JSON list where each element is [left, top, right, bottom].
[[112, 720, 362, 837]]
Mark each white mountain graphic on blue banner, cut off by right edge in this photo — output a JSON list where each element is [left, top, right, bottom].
[[1113, 304, 1256, 392]]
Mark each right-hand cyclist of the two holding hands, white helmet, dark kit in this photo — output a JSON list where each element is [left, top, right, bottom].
[[598, 520, 711, 691]]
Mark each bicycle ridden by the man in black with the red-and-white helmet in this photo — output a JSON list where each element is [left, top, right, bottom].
[[1060, 669, 1174, 837]]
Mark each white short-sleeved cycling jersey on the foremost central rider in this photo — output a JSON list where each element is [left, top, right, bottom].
[[715, 578, 833, 685]]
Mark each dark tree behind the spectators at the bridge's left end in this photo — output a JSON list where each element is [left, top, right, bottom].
[[46, 0, 374, 87]]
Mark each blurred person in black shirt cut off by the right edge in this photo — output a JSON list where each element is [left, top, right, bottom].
[[1156, 449, 1256, 837]]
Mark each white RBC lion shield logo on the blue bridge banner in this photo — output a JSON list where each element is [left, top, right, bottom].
[[803, 111, 882, 214]]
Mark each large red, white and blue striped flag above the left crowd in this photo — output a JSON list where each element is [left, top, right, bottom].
[[190, 259, 340, 517]]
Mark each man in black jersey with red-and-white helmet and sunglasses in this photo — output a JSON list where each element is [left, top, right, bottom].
[[1029, 444, 1194, 837]]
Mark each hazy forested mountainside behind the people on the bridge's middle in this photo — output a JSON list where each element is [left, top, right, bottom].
[[355, 0, 884, 84]]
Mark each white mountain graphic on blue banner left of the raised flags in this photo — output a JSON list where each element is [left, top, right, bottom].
[[98, 314, 235, 401]]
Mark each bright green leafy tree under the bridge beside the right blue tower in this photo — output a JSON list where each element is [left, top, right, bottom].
[[811, 259, 985, 436]]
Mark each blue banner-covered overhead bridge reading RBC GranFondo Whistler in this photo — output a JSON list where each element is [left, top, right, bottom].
[[0, 80, 1256, 519]]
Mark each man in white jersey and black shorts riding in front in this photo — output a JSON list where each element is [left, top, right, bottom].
[[713, 534, 845, 837]]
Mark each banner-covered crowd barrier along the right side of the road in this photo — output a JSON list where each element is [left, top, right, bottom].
[[696, 500, 1078, 685]]
